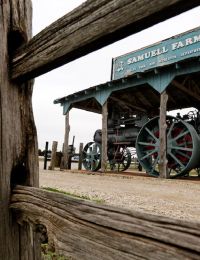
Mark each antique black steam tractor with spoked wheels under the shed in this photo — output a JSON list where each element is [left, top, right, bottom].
[[83, 108, 200, 177]]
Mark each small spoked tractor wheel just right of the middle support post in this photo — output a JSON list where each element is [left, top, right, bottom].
[[108, 147, 131, 172]]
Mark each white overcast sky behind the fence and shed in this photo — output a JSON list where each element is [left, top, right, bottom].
[[32, 0, 200, 149]]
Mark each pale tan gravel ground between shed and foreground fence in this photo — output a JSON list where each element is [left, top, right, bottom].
[[40, 162, 200, 222]]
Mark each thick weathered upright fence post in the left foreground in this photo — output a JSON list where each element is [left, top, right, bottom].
[[0, 0, 40, 260]]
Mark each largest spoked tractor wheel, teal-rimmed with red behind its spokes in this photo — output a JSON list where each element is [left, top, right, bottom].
[[136, 116, 200, 178]]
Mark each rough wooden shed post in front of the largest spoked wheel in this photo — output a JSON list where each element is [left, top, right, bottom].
[[159, 91, 169, 179]]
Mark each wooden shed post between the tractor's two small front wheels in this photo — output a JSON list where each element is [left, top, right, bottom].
[[101, 101, 108, 172]]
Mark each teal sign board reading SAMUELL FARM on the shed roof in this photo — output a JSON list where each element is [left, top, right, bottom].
[[112, 27, 200, 80]]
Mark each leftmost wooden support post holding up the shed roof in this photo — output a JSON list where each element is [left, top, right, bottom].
[[60, 112, 70, 169]]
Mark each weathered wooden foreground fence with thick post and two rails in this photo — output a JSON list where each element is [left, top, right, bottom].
[[0, 0, 200, 260]]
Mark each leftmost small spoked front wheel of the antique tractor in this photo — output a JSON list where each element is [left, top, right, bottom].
[[82, 142, 101, 172]]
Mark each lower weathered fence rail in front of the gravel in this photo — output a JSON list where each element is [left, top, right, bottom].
[[11, 186, 200, 260]]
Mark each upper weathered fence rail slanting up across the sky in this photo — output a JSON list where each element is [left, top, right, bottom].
[[11, 0, 199, 80]]
